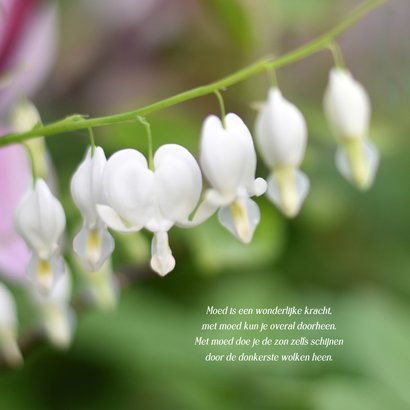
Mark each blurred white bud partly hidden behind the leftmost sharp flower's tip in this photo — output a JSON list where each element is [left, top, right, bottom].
[[32, 267, 75, 349]]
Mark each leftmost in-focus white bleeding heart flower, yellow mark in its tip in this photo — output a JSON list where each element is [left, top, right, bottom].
[[14, 179, 65, 292]]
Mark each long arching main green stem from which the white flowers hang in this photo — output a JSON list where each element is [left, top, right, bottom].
[[0, 0, 385, 147]]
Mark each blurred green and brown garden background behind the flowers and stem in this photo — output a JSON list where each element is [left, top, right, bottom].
[[0, 0, 410, 410]]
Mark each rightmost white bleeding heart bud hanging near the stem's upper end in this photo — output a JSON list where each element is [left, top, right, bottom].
[[323, 68, 379, 189]]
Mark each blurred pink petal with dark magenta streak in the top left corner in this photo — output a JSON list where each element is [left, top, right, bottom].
[[0, 0, 58, 118]]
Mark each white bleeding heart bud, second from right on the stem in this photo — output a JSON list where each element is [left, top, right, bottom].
[[255, 88, 309, 218]]
